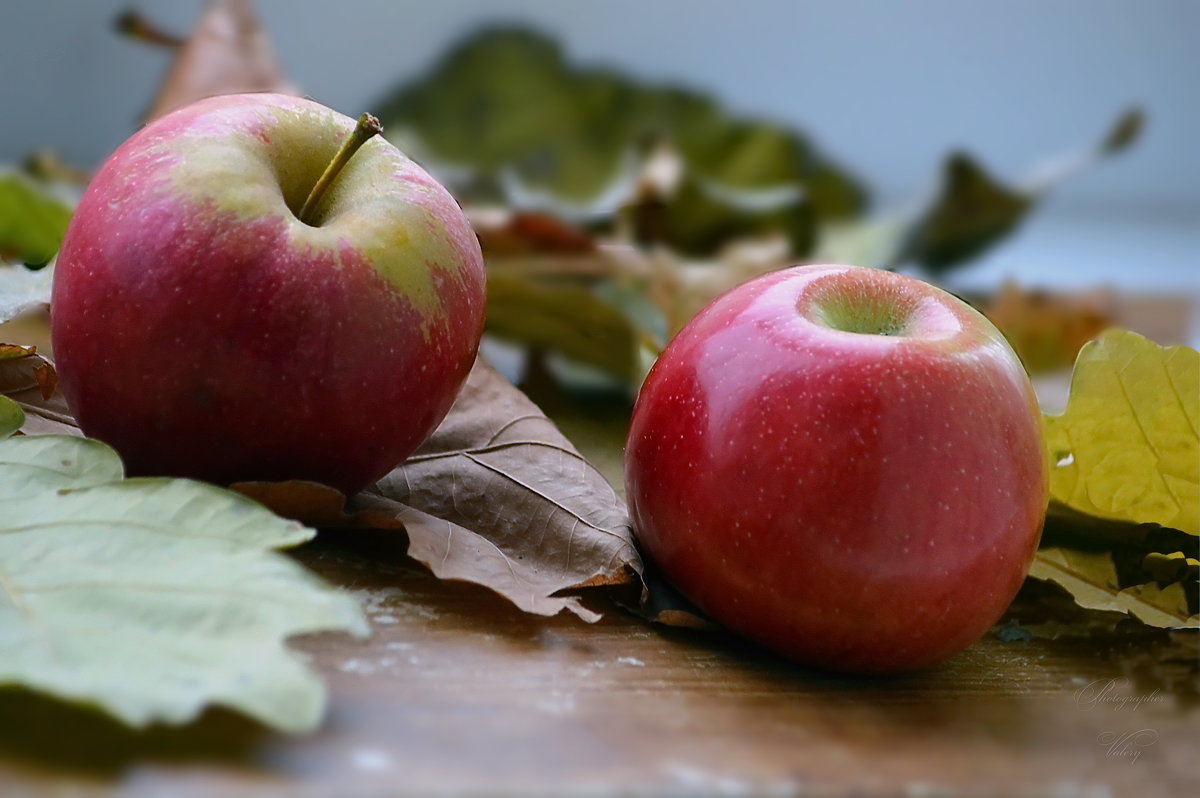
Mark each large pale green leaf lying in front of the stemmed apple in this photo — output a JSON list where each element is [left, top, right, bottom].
[[0, 436, 365, 732]]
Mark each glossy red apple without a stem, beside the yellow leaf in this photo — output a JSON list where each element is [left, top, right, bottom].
[[625, 265, 1046, 672]]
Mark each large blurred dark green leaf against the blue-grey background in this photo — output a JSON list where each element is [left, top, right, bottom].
[[377, 28, 865, 233]]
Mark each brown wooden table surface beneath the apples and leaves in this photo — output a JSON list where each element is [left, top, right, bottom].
[[0, 384, 1200, 798]]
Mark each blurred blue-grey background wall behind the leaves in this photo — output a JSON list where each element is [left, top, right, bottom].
[[0, 0, 1200, 295]]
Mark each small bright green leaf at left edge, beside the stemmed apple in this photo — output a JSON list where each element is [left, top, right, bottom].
[[0, 172, 71, 264]]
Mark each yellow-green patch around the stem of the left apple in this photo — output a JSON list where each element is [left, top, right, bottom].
[[144, 101, 462, 328]]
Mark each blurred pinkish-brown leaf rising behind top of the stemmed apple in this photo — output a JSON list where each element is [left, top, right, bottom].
[[145, 0, 296, 121]]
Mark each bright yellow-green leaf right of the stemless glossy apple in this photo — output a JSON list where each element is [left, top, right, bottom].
[[1045, 330, 1200, 535]]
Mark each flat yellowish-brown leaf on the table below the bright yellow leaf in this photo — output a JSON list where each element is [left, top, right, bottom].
[[1030, 547, 1200, 628]]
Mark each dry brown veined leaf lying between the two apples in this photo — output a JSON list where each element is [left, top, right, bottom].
[[352, 364, 641, 620]]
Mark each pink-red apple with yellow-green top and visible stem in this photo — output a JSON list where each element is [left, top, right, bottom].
[[52, 95, 485, 492]]
